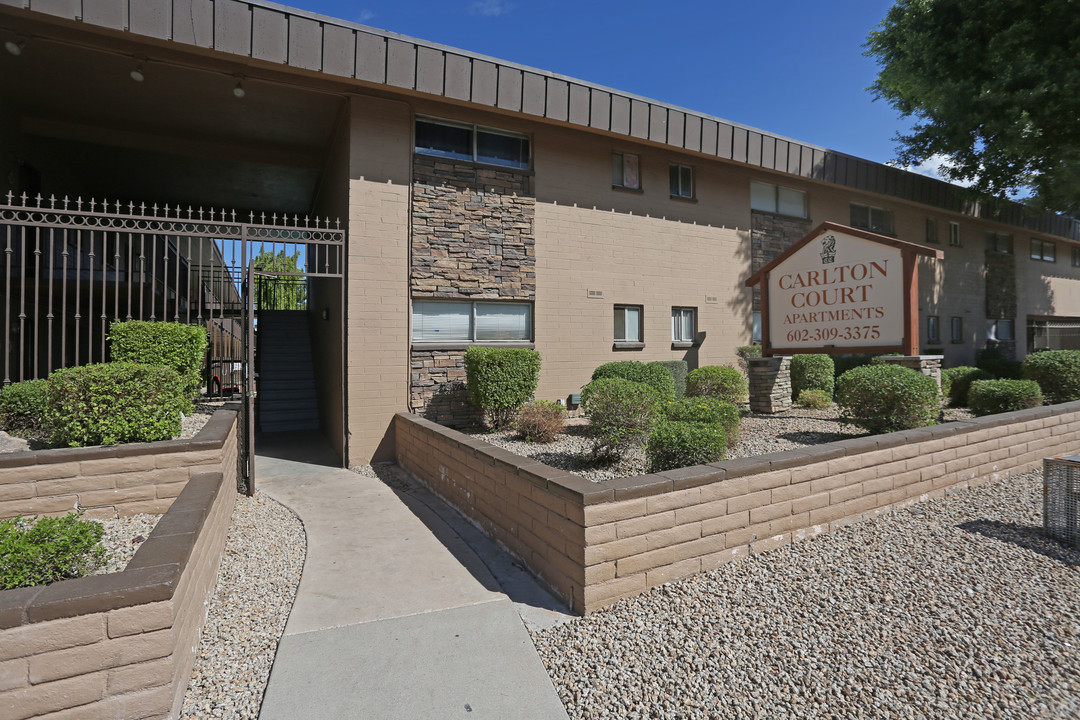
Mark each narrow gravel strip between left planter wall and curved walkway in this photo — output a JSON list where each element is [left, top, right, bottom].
[[180, 492, 304, 720]]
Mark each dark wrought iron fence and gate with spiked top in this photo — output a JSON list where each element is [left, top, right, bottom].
[[0, 192, 345, 493]]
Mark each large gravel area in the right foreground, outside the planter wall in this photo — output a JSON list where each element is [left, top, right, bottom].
[[532, 472, 1080, 720]]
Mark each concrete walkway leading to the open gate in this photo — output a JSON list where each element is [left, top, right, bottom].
[[256, 436, 568, 720]]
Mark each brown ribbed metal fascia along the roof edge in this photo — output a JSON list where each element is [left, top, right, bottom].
[[8, 0, 1080, 241]]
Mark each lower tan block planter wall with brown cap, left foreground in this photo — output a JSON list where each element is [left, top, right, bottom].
[[0, 410, 237, 720]]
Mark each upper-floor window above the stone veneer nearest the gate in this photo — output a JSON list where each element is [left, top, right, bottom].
[[415, 118, 530, 168]]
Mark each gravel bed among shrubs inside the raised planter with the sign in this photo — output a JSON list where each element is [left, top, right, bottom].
[[473, 406, 971, 483]]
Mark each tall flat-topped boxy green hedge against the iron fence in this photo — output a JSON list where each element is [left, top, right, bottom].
[[109, 320, 206, 405]]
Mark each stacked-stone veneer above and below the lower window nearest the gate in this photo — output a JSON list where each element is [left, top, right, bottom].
[[409, 155, 536, 426]]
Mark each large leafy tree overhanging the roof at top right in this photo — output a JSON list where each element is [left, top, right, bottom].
[[866, 0, 1080, 212]]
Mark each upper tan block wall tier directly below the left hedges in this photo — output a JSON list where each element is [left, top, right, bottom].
[[0, 409, 237, 519]]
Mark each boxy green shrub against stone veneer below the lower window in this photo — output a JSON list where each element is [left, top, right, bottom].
[[465, 348, 540, 427]]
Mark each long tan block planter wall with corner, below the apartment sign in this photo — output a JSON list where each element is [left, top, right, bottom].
[[394, 402, 1080, 613]]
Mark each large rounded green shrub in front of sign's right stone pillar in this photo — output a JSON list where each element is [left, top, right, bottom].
[[836, 365, 941, 433]]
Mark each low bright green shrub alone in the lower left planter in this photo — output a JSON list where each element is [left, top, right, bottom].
[[0, 511, 107, 590]]
